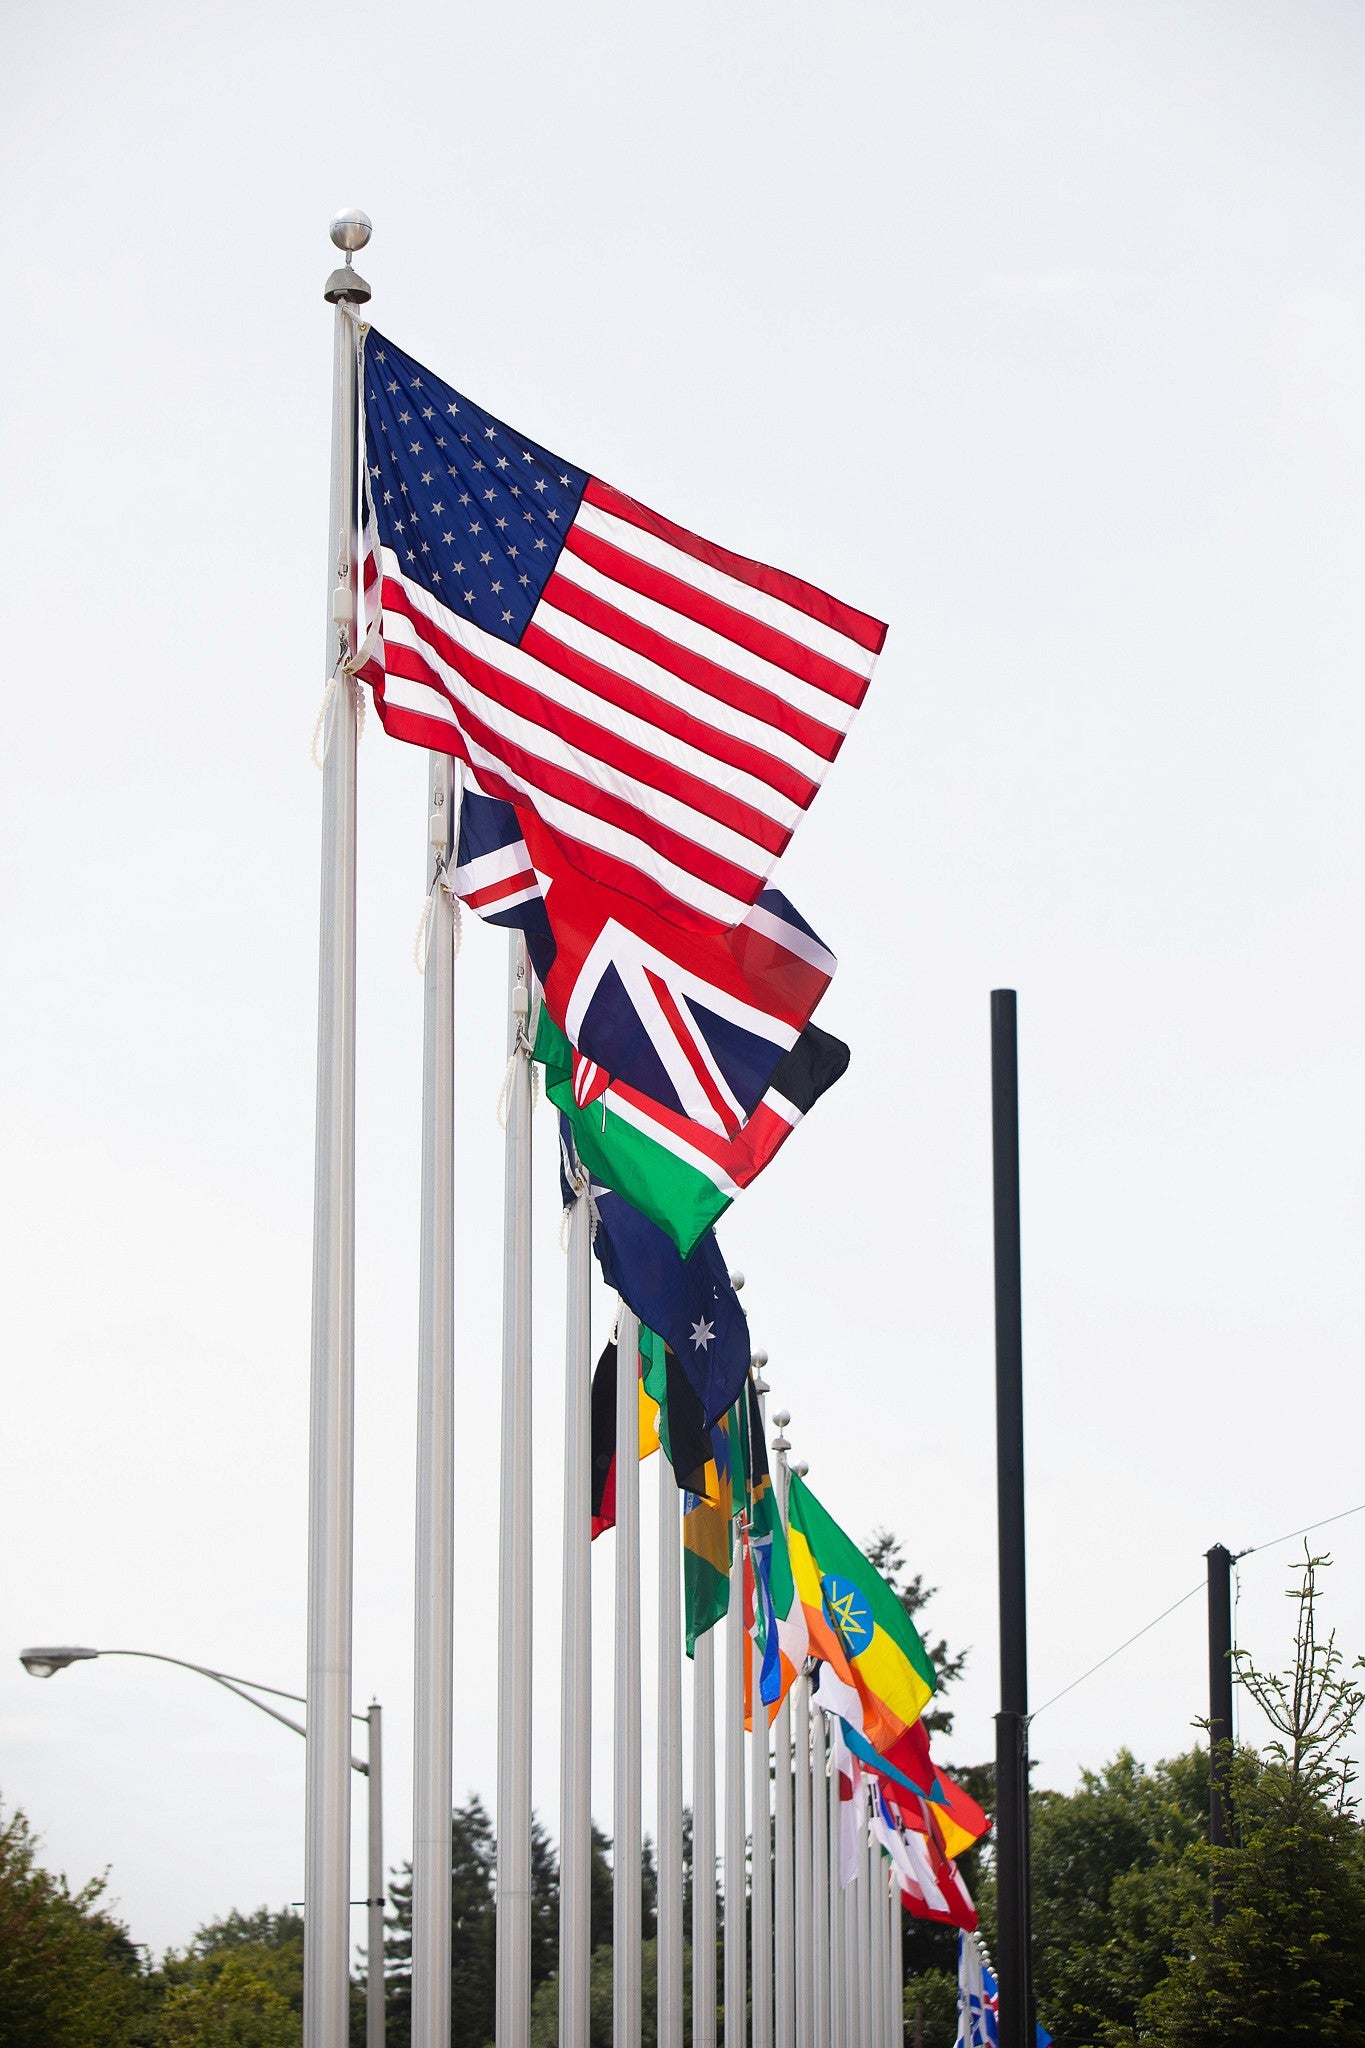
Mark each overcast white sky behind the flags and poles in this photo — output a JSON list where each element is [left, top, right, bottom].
[[0, 0, 1365, 1948]]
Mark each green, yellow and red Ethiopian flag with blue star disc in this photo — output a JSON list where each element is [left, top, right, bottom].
[[788, 1473, 935, 1753]]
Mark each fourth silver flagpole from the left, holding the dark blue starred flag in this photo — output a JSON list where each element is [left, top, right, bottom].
[[559, 1176, 591, 2048]]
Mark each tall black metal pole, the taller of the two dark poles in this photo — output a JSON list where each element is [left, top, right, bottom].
[[990, 989, 1033, 2048]]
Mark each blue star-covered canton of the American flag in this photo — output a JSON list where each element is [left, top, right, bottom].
[[364, 328, 587, 647]]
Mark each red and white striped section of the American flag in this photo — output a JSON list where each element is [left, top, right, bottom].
[[360, 477, 886, 926]]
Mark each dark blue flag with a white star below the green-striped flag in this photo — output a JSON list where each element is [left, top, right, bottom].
[[591, 1182, 749, 1427]]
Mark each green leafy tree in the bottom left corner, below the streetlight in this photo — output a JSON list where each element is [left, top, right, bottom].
[[0, 1810, 153, 2048]]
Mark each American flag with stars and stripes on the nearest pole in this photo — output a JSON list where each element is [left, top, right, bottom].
[[356, 330, 886, 926]]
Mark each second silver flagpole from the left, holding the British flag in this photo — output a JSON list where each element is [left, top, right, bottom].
[[411, 754, 456, 2048]]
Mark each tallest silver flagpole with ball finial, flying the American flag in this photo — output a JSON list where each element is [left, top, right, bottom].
[[303, 211, 370, 2048]]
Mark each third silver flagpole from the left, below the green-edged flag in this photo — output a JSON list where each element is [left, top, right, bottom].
[[493, 932, 530, 2048]]
